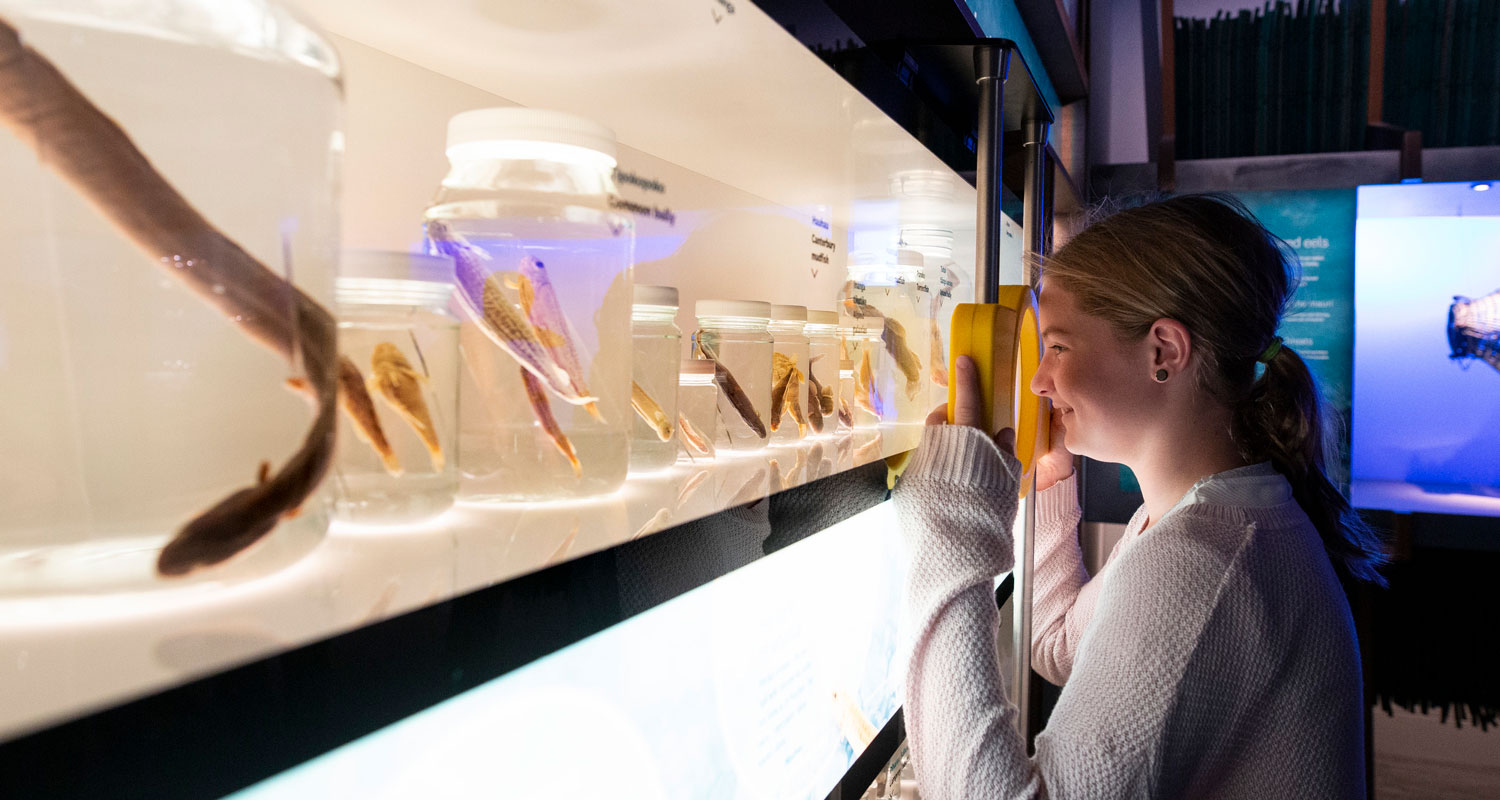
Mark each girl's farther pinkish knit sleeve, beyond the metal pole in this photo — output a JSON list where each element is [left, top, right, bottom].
[[1032, 474, 1103, 686]]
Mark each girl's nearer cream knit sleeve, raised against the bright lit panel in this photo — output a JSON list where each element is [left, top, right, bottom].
[[896, 425, 1044, 800]]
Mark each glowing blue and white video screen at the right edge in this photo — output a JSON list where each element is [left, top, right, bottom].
[[1352, 182, 1500, 515]]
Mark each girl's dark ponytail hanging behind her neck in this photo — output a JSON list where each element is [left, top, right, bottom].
[[1235, 347, 1386, 585]]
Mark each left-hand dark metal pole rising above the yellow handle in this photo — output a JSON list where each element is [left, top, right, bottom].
[[974, 45, 1011, 303]]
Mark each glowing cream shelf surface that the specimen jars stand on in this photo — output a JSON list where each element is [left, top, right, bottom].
[[0, 425, 921, 740]]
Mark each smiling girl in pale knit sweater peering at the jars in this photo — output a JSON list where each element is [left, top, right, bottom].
[[896, 195, 1382, 800]]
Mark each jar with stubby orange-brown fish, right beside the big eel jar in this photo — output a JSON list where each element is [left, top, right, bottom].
[[335, 251, 459, 524]]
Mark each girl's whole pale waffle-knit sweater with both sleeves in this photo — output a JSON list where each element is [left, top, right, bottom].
[[896, 426, 1365, 800]]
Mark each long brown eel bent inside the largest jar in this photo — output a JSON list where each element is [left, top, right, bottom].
[[0, 20, 339, 575]]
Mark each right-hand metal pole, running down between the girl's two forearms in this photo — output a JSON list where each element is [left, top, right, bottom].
[[1011, 114, 1049, 741]]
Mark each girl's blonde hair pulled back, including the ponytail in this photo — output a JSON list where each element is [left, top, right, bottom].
[[1043, 194, 1386, 584]]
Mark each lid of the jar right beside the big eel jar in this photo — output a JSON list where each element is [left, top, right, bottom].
[[335, 251, 453, 308]]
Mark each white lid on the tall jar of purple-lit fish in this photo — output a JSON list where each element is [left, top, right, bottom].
[[447, 107, 615, 162]]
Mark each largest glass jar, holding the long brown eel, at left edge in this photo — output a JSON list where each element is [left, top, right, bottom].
[[0, 0, 342, 596]]
